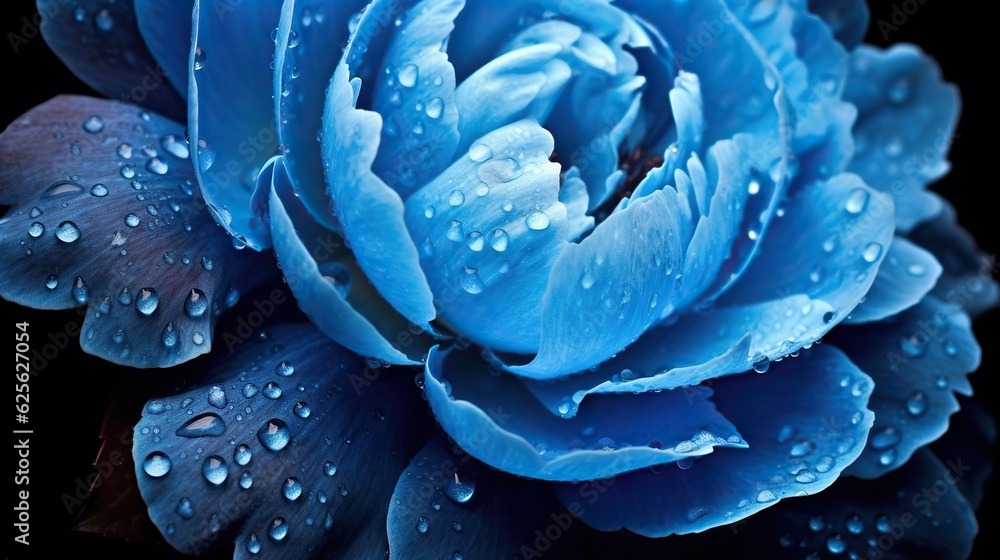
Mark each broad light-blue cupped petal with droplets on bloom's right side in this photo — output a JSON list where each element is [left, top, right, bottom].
[[719, 173, 893, 346]]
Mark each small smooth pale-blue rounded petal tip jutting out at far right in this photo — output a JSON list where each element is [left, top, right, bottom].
[[845, 237, 941, 323]]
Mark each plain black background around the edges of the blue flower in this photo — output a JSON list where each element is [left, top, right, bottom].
[[0, 0, 1000, 559]]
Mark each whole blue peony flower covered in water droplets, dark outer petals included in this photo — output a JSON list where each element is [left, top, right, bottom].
[[0, 0, 998, 559]]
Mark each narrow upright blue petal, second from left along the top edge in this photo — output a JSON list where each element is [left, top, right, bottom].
[[274, 0, 367, 231]]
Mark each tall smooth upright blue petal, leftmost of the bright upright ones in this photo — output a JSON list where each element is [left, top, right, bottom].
[[188, 0, 280, 250]]
